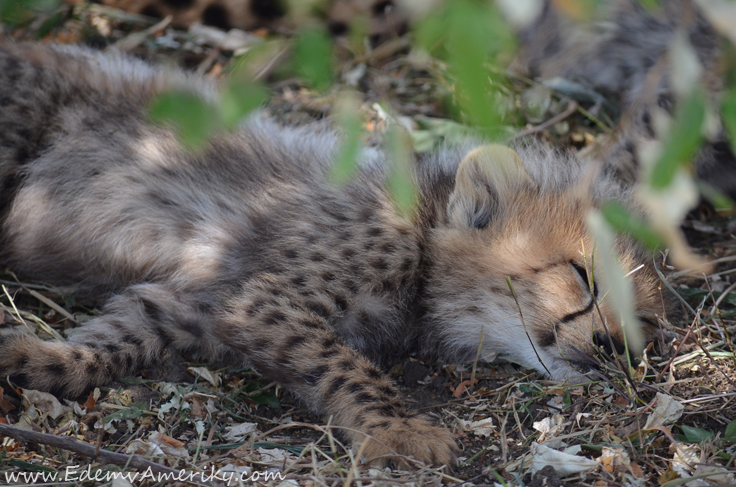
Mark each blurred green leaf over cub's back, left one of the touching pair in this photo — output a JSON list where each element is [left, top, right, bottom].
[[149, 91, 219, 149]]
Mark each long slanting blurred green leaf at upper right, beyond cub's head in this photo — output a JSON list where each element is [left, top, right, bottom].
[[650, 93, 705, 189]]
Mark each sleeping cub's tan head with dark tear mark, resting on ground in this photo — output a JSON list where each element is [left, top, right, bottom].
[[427, 146, 662, 379]]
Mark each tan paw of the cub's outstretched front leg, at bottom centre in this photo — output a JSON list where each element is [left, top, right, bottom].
[[360, 416, 457, 468]]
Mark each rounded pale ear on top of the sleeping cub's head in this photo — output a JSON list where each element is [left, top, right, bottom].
[[447, 144, 533, 229]]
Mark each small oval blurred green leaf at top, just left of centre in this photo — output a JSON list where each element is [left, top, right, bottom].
[[294, 27, 333, 90]]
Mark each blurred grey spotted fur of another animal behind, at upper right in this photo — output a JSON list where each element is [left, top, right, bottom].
[[516, 0, 736, 199]]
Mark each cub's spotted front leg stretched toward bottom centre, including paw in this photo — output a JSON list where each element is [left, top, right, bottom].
[[221, 279, 456, 466]]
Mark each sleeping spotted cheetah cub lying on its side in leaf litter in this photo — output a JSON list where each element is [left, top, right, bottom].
[[0, 44, 659, 464]]
